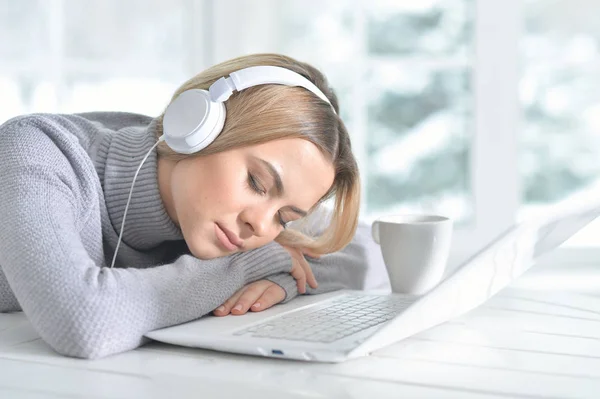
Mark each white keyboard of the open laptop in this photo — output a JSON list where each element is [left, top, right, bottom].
[[234, 294, 417, 343]]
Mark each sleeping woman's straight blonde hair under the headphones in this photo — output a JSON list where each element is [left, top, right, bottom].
[[157, 54, 360, 254]]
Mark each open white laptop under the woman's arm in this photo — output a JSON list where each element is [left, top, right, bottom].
[[146, 204, 600, 362]]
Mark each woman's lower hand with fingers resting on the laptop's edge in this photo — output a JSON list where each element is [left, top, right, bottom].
[[213, 280, 285, 316]]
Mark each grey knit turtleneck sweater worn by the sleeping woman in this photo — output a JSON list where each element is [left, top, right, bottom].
[[0, 113, 366, 358]]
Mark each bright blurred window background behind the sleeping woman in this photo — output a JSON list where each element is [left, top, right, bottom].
[[0, 0, 600, 261]]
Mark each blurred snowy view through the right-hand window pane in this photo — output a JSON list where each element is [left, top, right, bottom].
[[519, 0, 600, 246]]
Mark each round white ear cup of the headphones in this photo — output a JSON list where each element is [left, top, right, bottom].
[[163, 89, 226, 154]]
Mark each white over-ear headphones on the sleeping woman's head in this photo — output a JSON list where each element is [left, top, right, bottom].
[[161, 66, 335, 154]]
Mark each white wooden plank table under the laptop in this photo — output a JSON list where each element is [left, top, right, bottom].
[[0, 265, 600, 399]]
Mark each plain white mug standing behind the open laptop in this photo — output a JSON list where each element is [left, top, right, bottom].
[[371, 215, 452, 295]]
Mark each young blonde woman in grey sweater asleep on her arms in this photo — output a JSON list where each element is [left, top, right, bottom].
[[0, 54, 366, 358]]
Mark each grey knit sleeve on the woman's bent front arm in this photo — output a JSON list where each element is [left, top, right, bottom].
[[0, 120, 291, 358]]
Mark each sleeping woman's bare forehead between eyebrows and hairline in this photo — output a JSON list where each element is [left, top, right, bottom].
[[247, 138, 334, 205]]
